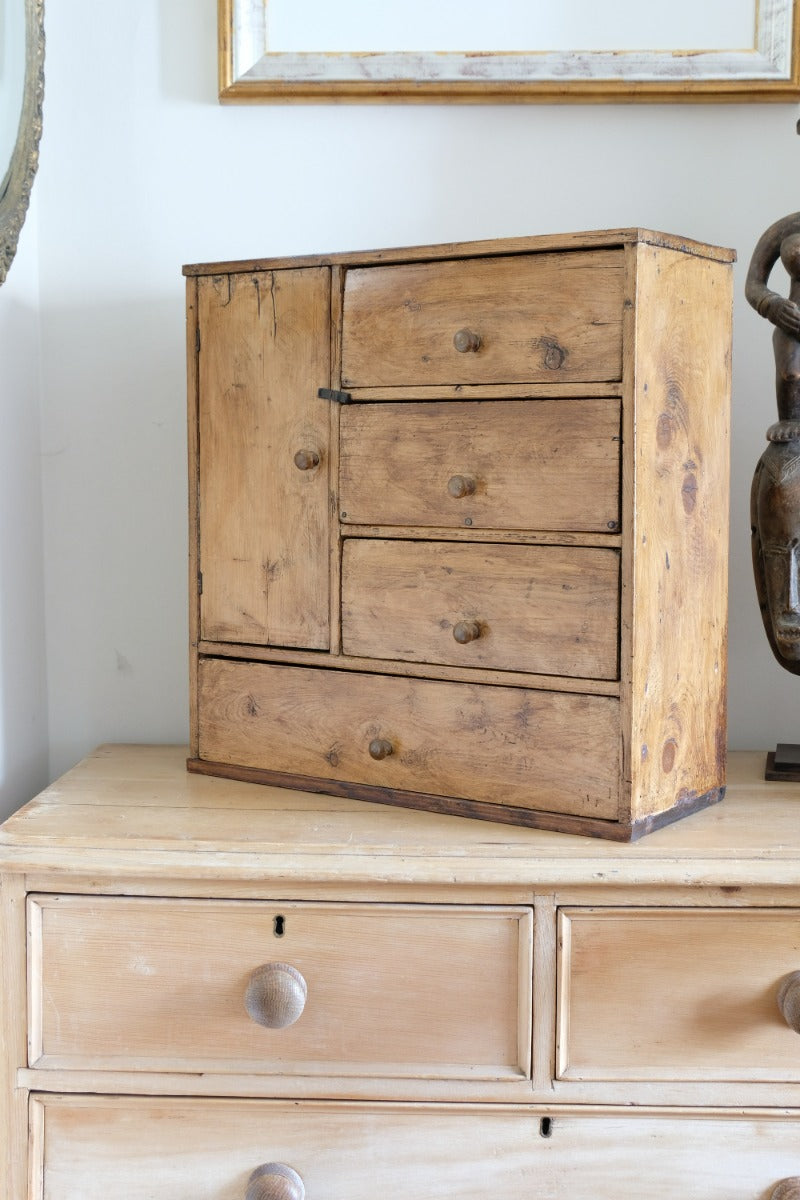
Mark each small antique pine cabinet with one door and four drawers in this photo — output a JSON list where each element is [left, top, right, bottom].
[[185, 229, 734, 840]]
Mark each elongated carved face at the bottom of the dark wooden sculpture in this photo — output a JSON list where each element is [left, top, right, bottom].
[[751, 439, 800, 674]]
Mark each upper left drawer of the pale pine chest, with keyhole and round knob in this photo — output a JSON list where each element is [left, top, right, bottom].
[[29, 896, 533, 1080]]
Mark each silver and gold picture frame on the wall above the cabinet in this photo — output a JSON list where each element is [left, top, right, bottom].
[[217, 0, 800, 103]]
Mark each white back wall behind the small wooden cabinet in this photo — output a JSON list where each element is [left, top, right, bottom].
[[25, 0, 800, 773]]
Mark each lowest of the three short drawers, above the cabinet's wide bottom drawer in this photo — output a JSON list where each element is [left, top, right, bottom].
[[342, 539, 619, 679]]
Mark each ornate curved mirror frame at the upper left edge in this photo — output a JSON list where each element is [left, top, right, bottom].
[[0, 0, 44, 283]]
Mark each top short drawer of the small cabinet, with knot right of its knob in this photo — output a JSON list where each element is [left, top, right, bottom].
[[342, 250, 624, 388]]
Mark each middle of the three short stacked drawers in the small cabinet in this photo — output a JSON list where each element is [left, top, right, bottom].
[[339, 398, 620, 533]]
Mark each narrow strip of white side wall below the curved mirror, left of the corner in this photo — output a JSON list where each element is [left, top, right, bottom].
[[0, 202, 48, 817]]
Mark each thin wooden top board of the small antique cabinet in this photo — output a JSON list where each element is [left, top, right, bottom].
[[184, 228, 736, 276]]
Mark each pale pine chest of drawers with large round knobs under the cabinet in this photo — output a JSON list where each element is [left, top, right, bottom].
[[0, 746, 800, 1200]]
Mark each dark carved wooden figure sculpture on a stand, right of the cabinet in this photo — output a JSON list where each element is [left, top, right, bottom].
[[745, 212, 800, 780]]
